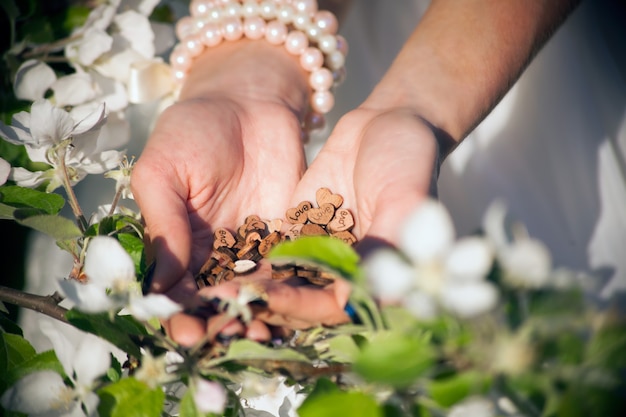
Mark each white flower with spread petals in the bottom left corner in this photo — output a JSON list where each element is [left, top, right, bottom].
[[0, 321, 111, 417]]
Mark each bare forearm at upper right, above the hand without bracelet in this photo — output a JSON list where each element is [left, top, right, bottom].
[[363, 0, 578, 142]]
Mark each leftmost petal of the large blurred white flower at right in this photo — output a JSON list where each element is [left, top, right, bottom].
[[364, 249, 414, 301]]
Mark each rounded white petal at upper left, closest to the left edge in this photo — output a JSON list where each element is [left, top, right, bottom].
[[13, 59, 57, 101]]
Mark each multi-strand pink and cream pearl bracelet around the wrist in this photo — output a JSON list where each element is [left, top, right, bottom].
[[170, 0, 348, 130]]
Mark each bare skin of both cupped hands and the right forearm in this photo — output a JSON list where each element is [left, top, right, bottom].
[[132, 0, 576, 345]]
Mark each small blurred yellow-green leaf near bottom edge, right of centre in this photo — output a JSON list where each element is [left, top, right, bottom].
[[428, 371, 491, 407]]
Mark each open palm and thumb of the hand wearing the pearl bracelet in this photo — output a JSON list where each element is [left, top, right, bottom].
[[133, 95, 304, 283]]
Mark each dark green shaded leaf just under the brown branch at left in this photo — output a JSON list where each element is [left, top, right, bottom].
[[65, 309, 146, 358]]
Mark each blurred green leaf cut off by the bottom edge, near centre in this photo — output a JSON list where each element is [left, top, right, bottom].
[[298, 391, 383, 417]]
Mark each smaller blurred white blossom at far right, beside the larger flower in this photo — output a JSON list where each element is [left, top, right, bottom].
[[483, 201, 552, 288]]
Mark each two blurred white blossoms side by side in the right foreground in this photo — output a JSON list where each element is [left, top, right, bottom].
[[365, 199, 552, 319]]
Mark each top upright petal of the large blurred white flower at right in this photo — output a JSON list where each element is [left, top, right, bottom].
[[400, 199, 455, 263]]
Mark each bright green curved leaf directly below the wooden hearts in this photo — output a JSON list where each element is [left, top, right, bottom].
[[268, 236, 360, 278]]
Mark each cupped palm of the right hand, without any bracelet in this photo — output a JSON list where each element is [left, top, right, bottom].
[[292, 109, 436, 243]]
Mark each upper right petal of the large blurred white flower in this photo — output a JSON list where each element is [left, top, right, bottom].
[[446, 237, 493, 281]]
